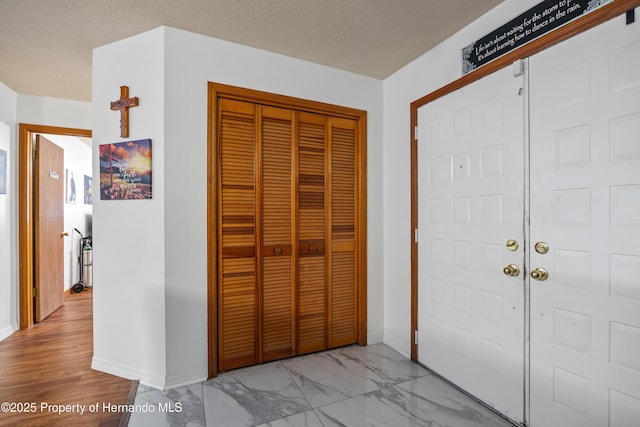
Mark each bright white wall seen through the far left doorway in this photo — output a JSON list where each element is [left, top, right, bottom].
[[43, 134, 93, 291]]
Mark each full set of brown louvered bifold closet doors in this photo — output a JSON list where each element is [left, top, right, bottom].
[[218, 95, 359, 371]]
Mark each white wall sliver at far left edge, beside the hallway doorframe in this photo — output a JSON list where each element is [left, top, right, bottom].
[[0, 82, 18, 341]]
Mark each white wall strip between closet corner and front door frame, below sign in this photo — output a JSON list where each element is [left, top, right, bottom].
[[383, 0, 539, 356]]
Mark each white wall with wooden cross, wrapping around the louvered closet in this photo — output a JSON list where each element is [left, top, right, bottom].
[[93, 27, 384, 388]]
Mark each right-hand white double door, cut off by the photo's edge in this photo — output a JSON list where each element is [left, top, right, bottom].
[[529, 10, 640, 427]]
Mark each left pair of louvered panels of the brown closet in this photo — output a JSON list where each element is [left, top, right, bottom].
[[218, 100, 295, 370]]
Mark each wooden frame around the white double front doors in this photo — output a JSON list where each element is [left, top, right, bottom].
[[409, 0, 640, 362]]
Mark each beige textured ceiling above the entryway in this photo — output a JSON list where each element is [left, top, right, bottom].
[[0, 0, 502, 101]]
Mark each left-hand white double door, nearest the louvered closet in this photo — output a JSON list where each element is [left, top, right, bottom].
[[418, 67, 525, 422]]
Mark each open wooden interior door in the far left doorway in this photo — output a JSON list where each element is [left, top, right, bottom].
[[34, 135, 64, 322]]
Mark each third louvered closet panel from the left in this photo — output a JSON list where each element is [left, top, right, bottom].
[[297, 113, 327, 354]]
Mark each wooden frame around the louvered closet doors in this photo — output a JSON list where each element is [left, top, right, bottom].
[[207, 82, 367, 378]]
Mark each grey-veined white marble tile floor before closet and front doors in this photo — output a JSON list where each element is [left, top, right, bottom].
[[129, 344, 512, 427]]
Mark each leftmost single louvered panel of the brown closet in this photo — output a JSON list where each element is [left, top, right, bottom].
[[218, 100, 259, 371]]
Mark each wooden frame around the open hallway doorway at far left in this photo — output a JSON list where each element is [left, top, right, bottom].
[[18, 123, 92, 329]]
